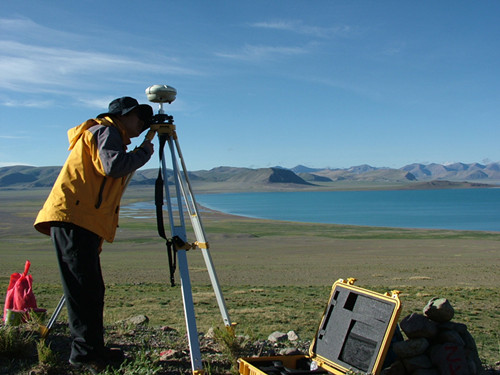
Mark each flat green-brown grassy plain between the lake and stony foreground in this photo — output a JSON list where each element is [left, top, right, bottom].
[[0, 188, 500, 364]]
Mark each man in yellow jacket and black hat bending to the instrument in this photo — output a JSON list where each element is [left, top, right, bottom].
[[34, 97, 153, 373]]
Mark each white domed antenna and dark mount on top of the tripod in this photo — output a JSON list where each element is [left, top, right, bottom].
[[146, 85, 177, 135]]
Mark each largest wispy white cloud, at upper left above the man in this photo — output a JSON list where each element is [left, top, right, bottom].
[[0, 18, 202, 100]]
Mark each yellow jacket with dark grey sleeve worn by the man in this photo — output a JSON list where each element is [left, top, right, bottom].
[[34, 117, 151, 242]]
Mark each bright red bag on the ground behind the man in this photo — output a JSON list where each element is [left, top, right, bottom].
[[3, 260, 37, 321]]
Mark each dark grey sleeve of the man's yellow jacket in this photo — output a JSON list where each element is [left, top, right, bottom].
[[94, 126, 151, 178]]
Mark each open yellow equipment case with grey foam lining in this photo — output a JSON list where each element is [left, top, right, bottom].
[[238, 279, 401, 375]]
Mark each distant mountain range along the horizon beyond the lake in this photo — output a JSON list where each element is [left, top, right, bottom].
[[0, 162, 500, 191]]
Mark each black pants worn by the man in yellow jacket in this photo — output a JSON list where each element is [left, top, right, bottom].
[[50, 222, 105, 360]]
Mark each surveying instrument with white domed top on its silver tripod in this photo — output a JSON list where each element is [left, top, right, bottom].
[[146, 85, 234, 375]]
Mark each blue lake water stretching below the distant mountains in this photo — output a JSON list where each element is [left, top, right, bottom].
[[121, 188, 500, 231]]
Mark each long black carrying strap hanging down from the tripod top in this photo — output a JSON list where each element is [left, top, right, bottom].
[[155, 135, 177, 286]]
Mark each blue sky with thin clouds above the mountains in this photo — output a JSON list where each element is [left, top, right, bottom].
[[0, 0, 500, 170]]
